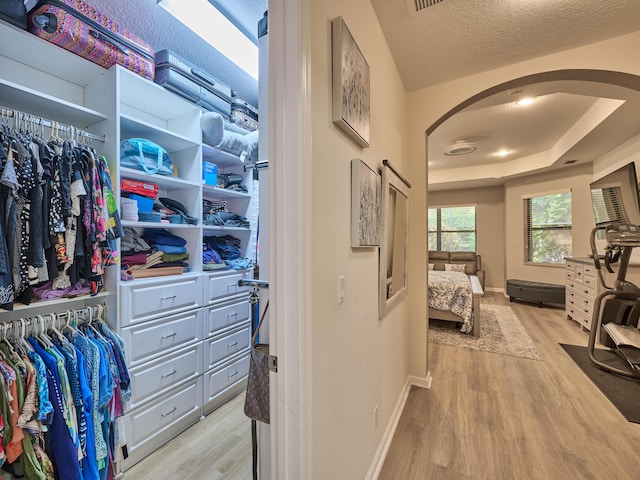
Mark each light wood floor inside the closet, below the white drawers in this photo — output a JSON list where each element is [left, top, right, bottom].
[[124, 393, 252, 480]]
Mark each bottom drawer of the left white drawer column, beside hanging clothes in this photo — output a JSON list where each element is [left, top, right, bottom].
[[124, 376, 203, 468]]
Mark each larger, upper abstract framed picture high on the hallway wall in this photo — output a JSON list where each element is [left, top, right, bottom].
[[332, 17, 370, 148]]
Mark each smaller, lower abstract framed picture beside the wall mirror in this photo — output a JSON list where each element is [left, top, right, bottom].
[[351, 158, 382, 247]]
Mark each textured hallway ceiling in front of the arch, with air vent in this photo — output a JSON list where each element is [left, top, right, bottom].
[[371, 0, 640, 91]]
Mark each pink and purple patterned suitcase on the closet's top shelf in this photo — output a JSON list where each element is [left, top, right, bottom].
[[28, 0, 155, 80]]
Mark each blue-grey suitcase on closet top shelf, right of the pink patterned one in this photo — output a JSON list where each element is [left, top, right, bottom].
[[154, 49, 234, 118]]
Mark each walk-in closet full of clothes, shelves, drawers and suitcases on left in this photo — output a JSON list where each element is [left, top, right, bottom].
[[0, 0, 269, 480]]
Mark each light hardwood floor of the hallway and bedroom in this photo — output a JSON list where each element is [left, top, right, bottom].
[[379, 292, 640, 480]]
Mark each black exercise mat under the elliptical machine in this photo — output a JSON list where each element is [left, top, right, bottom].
[[560, 343, 640, 423]]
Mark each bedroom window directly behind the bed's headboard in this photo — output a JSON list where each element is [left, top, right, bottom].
[[428, 205, 476, 252]]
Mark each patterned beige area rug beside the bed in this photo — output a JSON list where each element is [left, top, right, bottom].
[[429, 305, 542, 360]]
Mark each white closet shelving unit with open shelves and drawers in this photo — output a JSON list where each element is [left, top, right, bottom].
[[0, 22, 255, 471]]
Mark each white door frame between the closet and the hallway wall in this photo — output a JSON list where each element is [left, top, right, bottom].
[[268, 0, 312, 480]]
